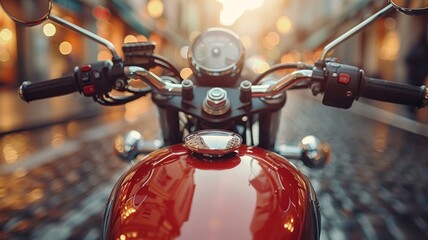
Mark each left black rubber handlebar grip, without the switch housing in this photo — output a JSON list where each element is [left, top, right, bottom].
[[19, 76, 78, 102]]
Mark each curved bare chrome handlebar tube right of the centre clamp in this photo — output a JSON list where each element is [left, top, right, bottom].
[[251, 70, 312, 97]]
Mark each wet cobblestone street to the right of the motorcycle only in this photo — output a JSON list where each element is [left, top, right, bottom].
[[281, 94, 428, 239]]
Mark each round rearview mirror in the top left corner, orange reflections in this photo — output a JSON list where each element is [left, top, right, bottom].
[[0, 0, 52, 26]]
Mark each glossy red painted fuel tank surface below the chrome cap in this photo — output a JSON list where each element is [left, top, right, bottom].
[[106, 145, 314, 240]]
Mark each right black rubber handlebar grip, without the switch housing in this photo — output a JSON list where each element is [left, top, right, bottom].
[[360, 77, 426, 107]]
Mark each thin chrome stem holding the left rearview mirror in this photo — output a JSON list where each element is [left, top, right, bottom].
[[49, 14, 120, 62]]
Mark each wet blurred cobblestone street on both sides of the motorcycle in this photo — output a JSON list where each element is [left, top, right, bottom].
[[0, 93, 428, 240]]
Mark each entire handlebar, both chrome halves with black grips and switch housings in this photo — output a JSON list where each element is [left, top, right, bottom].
[[19, 61, 428, 108]]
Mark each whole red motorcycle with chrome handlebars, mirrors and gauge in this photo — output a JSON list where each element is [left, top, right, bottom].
[[0, 0, 428, 239]]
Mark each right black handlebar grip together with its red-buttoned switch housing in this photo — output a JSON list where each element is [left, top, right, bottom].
[[318, 61, 428, 109]]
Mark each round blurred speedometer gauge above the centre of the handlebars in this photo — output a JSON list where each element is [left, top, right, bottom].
[[188, 28, 245, 81]]
